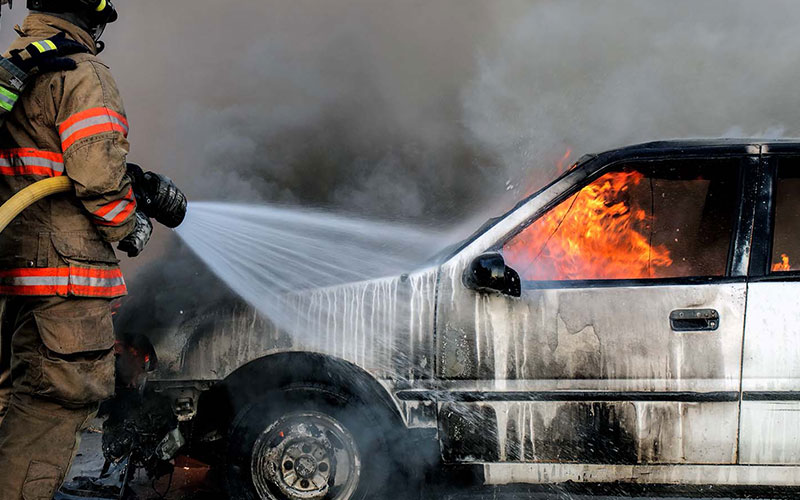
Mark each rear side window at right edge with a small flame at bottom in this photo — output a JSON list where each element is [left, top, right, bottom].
[[771, 158, 800, 273]]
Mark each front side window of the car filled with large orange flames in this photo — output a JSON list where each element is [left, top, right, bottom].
[[502, 159, 740, 281]]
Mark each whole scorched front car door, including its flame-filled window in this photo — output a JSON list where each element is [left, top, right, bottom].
[[437, 151, 757, 464]]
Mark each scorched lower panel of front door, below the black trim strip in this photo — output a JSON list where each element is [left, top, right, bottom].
[[438, 398, 738, 464]]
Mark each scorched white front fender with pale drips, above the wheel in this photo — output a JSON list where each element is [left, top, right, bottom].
[[150, 268, 437, 381]]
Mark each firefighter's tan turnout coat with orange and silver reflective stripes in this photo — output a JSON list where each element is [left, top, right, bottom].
[[0, 13, 136, 298]]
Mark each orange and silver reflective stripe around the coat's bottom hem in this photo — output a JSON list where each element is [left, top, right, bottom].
[[0, 265, 127, 298]]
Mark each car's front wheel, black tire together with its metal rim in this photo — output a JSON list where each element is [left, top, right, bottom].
[[225, 383, 398, 500]]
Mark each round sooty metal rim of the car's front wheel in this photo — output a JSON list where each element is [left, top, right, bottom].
[[251, 412, 361, 500]]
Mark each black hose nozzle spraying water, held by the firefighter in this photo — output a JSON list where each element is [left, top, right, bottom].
[[128, 163, 191, 228]]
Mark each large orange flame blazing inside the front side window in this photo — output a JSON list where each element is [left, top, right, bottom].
[[503, 167, 672, 281]]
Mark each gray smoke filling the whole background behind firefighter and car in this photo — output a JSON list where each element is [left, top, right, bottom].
[[3, 0, 800, 330]]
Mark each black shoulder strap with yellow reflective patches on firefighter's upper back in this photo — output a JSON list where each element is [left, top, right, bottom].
[[8, 32, 89, 75]]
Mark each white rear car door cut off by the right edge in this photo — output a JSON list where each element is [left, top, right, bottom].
[[740, 149, 800, 465]]
